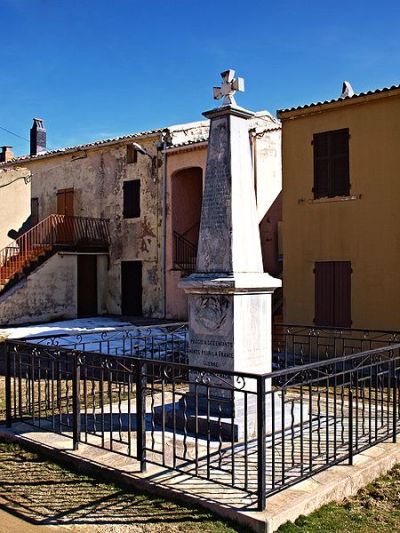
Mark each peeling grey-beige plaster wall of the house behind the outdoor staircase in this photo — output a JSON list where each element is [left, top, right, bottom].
[[29, 137, 161, 316]]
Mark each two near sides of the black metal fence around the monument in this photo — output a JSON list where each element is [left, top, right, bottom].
[[5, 341, 400, 510]]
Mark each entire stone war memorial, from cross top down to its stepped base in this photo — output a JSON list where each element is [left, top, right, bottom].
[[164, 70, 281, 441]]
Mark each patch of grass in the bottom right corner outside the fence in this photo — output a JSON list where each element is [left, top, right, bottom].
[[278, 465, 400, 533]]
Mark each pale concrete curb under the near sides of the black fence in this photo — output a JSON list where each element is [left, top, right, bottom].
[[0, 423, 400, 533]]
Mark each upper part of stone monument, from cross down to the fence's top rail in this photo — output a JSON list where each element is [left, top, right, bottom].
[[180, 70, 281, 436]]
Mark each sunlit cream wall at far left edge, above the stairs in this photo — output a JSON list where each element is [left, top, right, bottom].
[[0, 168, 31, 250]]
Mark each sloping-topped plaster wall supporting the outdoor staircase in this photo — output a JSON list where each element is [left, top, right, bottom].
[[0, 254, 77, 326]]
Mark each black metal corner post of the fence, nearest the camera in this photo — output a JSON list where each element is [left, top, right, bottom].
[[257, 376, 266, 511]]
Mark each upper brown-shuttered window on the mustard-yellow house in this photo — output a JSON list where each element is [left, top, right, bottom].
[[313, 129, 350, 198]]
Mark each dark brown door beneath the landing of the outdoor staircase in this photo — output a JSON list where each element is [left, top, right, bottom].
[[78, 255, 97, 317]]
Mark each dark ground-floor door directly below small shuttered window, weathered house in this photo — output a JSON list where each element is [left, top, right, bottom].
[[121, 261, 143, 316]]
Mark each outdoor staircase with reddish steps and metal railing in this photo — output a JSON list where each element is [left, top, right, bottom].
[[0, 214, 110, 294]]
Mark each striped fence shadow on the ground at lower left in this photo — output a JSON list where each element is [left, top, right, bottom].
[[0, 443, 235, 532]]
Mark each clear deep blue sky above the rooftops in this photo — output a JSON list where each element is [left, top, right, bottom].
[[0, 0, 400, 154]]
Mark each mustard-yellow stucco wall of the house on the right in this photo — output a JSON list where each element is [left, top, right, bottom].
[[283, 95, 400, 329]]
